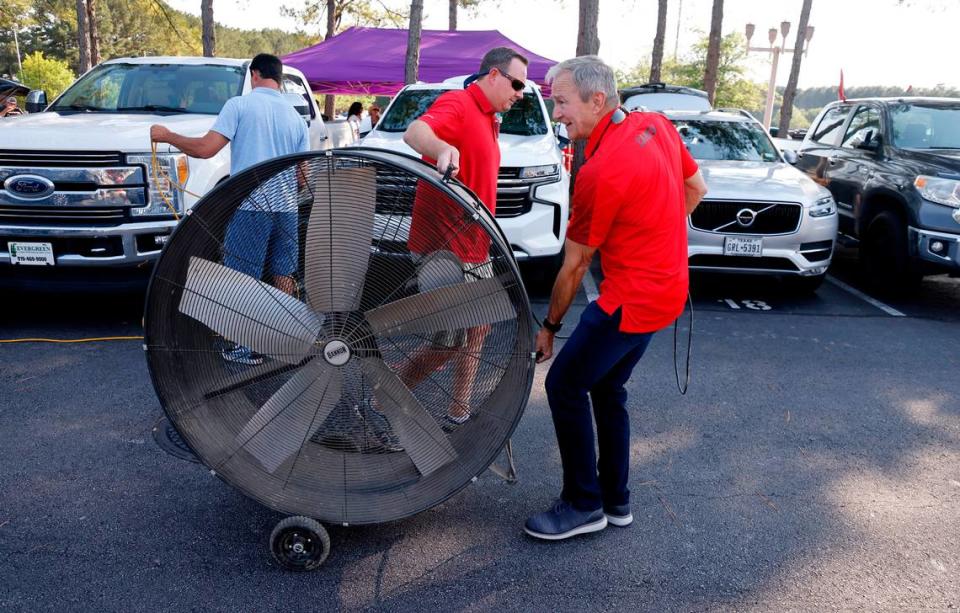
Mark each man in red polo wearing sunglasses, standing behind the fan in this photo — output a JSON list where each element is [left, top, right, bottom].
[[400, 47, 527, 426]]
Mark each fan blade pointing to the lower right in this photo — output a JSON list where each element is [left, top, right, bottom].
[[361, 358, 457, 476]]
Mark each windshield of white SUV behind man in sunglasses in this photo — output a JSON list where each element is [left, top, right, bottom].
[[377, 89, 549, 136]]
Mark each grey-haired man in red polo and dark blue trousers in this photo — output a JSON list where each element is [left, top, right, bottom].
[[525, 56, 706, 540]]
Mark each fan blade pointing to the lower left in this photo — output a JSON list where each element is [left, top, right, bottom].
[[237, 360, 342, 472]]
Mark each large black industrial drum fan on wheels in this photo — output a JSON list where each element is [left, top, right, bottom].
[[145, 148, 535, 570]]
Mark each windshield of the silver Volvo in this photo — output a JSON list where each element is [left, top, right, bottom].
[[673, 120, 780, 162]]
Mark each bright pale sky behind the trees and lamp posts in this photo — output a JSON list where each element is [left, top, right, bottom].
[[167, 0, 960, 88]]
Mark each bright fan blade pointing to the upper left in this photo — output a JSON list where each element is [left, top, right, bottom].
[[180, 257, 321, 364]]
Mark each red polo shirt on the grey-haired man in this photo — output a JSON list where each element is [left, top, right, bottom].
[[567, 107, 697, 332]]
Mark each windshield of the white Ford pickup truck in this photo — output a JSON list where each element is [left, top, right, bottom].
[[48, 64, 244, 115]]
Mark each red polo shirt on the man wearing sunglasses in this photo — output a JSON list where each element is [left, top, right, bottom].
[[407, 83, 500, 263]]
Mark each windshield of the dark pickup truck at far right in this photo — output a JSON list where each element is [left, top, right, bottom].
[[890, 102, 960, 149]]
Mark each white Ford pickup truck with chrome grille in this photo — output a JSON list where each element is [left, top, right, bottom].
[[0, 57, 329, 285]]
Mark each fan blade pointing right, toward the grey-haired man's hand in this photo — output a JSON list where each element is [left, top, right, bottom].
[[366, 278, 517, 336]]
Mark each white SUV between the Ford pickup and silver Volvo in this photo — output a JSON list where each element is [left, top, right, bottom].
[[360, 77, 570, 268]]
